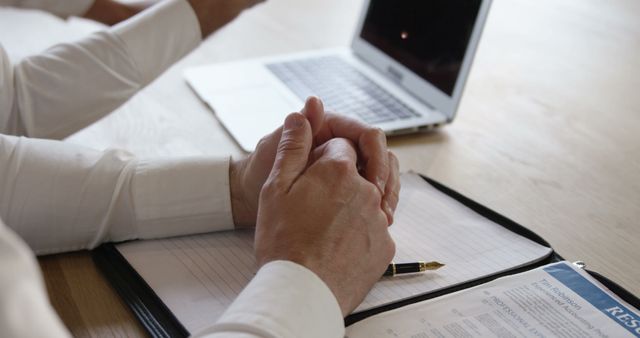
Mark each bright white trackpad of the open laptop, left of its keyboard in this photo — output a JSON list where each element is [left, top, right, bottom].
[[209, 84, 302, 151]]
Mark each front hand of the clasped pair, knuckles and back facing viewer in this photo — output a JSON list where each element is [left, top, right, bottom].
[[255, 113, 395, 315]]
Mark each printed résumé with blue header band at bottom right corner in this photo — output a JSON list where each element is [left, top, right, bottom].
[[347, 262, 640, 338]]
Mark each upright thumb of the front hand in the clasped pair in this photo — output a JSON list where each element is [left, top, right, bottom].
[[269, 113, 312, 191]]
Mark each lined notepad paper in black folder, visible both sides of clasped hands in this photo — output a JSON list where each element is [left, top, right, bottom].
[[117, 173, 551, 332]]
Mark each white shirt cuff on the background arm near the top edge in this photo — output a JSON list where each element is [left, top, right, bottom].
[[111, 0, 202, 85]]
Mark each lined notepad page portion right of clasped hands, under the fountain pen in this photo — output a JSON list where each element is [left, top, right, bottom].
[[356, 173, 551, 311]]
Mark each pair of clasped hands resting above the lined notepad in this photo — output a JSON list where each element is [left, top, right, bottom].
[[229, 97, 400, 315]]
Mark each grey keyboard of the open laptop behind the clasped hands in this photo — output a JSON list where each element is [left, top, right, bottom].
[[267, 56, 419, 124]]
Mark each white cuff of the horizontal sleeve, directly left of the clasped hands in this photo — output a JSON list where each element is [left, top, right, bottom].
[[109, 157, 234, 241]]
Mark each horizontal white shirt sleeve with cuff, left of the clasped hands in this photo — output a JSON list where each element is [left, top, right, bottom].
[[0, 135, 233, 254]]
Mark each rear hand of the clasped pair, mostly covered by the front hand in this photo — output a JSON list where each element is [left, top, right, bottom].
[[229, 97, 400, 227]]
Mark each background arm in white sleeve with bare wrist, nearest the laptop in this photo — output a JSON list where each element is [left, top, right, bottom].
[[0, 0, 256, 139]]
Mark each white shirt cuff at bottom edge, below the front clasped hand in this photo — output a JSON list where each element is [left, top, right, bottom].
[[200, 261, 345, 338]]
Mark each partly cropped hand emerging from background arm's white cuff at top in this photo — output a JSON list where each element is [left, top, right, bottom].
[[188, 0, 265, 38]]
